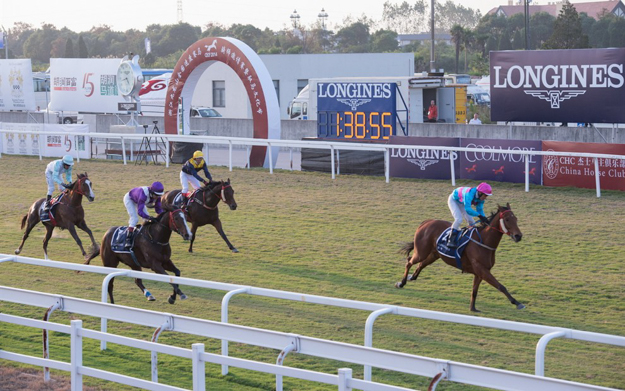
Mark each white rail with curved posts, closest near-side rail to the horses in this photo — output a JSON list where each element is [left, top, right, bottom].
[[0, 254, 625, 388]]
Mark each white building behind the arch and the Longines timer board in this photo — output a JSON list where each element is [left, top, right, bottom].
[[193, 53, 414, 119]]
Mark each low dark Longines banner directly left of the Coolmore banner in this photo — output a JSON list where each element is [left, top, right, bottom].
[[389, 136, 460, 179]]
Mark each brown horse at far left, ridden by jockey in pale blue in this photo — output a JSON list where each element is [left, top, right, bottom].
[[15, 173, 97, 259]]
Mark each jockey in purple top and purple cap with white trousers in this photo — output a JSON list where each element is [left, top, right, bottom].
[[124, 182, 165, 247]]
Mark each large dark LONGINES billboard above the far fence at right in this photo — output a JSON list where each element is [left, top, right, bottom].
[[490, 48, 625, 123]]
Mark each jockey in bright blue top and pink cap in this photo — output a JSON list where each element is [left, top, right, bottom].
[[447, 182, 493, 248]]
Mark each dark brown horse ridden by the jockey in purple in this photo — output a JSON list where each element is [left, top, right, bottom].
[[85, 209, 191, 304]]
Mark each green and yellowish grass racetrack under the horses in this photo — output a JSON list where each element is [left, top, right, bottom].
[[0, 155, 625, 390]]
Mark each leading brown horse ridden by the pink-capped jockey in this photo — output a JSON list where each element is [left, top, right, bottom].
[[395, 204, 525, 312]]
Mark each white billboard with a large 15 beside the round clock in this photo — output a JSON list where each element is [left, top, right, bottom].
[[50, 58, 124, 113]]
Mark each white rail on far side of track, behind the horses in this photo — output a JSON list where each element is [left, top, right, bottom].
[[0, 129, 625, 197]]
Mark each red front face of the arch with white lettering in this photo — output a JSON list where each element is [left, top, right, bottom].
[[165, 37, 271, 167]]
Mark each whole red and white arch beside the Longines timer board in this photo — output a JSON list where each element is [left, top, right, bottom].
[[165, 37, 280, 167]]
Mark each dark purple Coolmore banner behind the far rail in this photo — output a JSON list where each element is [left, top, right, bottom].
[[459, 138, 542, 185]]
